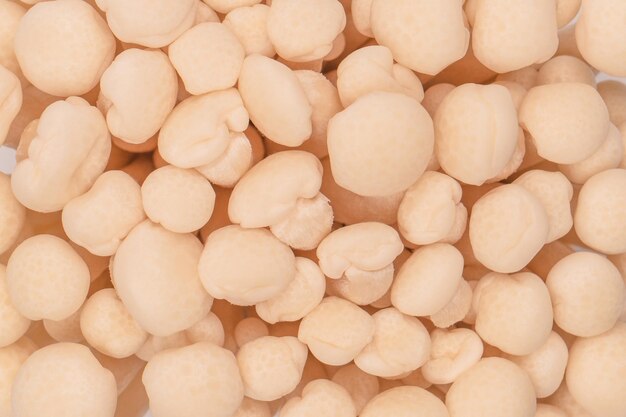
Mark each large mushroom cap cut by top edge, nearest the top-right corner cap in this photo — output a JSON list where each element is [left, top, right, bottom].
[[472, 0, 559, 73]]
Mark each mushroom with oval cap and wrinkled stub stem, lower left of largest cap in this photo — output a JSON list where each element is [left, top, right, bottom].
[[228, 151, 333, 250]]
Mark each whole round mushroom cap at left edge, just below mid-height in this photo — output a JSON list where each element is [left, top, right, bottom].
[[6, 235, 91, 320]]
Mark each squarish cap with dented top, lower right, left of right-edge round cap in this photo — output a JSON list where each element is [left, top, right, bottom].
[[473, 272, 553, 356]]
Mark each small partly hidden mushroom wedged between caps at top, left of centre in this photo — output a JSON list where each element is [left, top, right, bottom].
[[222, 4, 276, 58]]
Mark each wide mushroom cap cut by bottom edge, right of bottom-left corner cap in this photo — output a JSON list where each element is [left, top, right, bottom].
[[142, 342, 244, 417]]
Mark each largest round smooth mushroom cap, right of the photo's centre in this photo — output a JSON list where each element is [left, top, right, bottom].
[[328, 92, 434, 196]]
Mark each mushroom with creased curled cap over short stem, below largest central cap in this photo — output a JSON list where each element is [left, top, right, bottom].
[[316, 222, 403, 305]]
